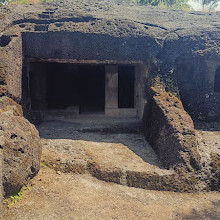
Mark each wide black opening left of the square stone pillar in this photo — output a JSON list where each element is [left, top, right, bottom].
[[30, 62, 105, 113]]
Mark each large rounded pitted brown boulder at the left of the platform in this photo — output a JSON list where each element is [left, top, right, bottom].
[[0, 112, 42, 195]]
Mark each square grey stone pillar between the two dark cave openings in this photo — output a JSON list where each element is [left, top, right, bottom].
[[105, 65, 118, 114]]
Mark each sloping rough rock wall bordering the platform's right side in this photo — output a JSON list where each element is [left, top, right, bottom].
[[144, 79, 200, 172]]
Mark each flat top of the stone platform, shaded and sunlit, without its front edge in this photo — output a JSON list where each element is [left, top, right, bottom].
[[38, 116, 162, 168]]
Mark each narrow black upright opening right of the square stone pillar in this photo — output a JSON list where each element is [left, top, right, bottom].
[[118, 65, 135, 108]]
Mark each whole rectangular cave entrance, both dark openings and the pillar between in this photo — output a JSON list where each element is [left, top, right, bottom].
[[28, 61, 140, 117]]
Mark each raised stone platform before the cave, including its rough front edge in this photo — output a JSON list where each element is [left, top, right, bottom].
[[38, 116, 173, 189]]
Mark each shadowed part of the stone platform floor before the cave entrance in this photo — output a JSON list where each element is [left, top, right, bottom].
[[38, 115, 162, 168]]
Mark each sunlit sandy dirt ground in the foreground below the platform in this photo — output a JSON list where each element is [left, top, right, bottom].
[[4, 167, 220, 220]]
